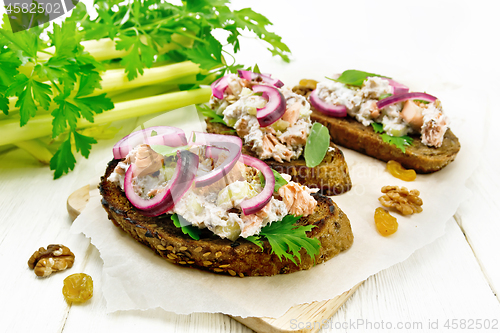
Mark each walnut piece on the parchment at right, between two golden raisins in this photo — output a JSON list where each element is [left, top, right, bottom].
[[378, 186, 423, 215]]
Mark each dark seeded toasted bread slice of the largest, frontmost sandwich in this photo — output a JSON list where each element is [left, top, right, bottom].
[[100, 160, 354, 277]]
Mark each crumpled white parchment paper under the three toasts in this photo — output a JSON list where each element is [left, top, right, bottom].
[[72, 82, 485, 317]]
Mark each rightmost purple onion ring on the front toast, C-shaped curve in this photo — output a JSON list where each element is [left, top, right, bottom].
[[240, 155, 276, 215]]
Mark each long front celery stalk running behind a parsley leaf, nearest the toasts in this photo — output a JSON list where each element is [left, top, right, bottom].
[[0, 88, 212, 146]]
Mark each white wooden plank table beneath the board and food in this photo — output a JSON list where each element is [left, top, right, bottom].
[[0, 0, 500, 333]]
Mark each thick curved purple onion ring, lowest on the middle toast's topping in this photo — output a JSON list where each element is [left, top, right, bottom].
[[252, 85, 286, 127]]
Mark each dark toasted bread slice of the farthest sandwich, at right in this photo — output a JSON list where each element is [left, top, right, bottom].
[[293, 86, 460, 173]]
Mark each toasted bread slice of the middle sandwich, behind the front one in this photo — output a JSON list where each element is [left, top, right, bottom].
[[205, 119, 352, 195]]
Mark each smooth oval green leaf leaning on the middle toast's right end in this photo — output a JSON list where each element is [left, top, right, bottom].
[[304, 123, 330, 168]]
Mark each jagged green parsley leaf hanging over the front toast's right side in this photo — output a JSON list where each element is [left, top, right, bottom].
[[246, 215, 321, 264]]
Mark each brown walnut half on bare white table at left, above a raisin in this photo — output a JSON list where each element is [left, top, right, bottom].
[[28, 244, 75, 277]]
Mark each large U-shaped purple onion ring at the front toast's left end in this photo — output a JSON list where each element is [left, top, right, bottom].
[[123, 150, 199, 216]]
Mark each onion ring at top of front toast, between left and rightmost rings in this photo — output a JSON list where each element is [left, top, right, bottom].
[[190, 132, 243, 187]]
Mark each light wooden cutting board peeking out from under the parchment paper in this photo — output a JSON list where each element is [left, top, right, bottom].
[[67, 185, 363, 333]]
